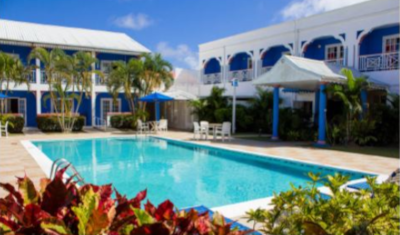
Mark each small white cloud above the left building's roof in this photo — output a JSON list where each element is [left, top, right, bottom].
[[113, 13, 153, 30]]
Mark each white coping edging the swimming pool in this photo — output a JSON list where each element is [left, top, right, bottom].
[[21, 135, 387, 218]]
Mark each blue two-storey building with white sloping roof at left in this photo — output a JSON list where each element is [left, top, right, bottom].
[[0, 20, 150, 127]]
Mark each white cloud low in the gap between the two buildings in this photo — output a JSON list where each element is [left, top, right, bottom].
[[156, 42, 199, 69]]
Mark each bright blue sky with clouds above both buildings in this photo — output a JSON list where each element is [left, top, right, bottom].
[[0, 0, 366, 68]]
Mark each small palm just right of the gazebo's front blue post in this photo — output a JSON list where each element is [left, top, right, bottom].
[[327, 68, 369, 143]]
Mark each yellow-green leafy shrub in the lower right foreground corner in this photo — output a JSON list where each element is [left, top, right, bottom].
[[248, 173, 400, 235]]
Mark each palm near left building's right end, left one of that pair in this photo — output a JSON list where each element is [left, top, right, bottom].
[[106, 59, 142, 114]]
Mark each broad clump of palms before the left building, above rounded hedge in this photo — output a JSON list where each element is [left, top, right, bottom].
[[29, 48, 102, 132]]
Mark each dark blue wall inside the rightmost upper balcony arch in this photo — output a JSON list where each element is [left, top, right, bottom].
[[360, 25, 399, 55]]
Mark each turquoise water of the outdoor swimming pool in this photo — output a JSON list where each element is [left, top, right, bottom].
[[32, 137, 367, 208]]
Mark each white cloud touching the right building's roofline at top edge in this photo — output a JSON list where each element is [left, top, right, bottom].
[[281, 0, 369, 20]]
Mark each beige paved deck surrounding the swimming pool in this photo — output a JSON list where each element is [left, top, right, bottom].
[[0, 129, 400, 227]]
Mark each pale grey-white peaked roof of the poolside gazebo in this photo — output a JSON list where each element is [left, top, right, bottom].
[[253, 55, 346, 90]]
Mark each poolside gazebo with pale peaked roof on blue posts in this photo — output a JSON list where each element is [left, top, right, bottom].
[[253, 56, 385, 146]]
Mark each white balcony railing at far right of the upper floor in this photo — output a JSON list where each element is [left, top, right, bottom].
[[358, 52, 399, 72]]
